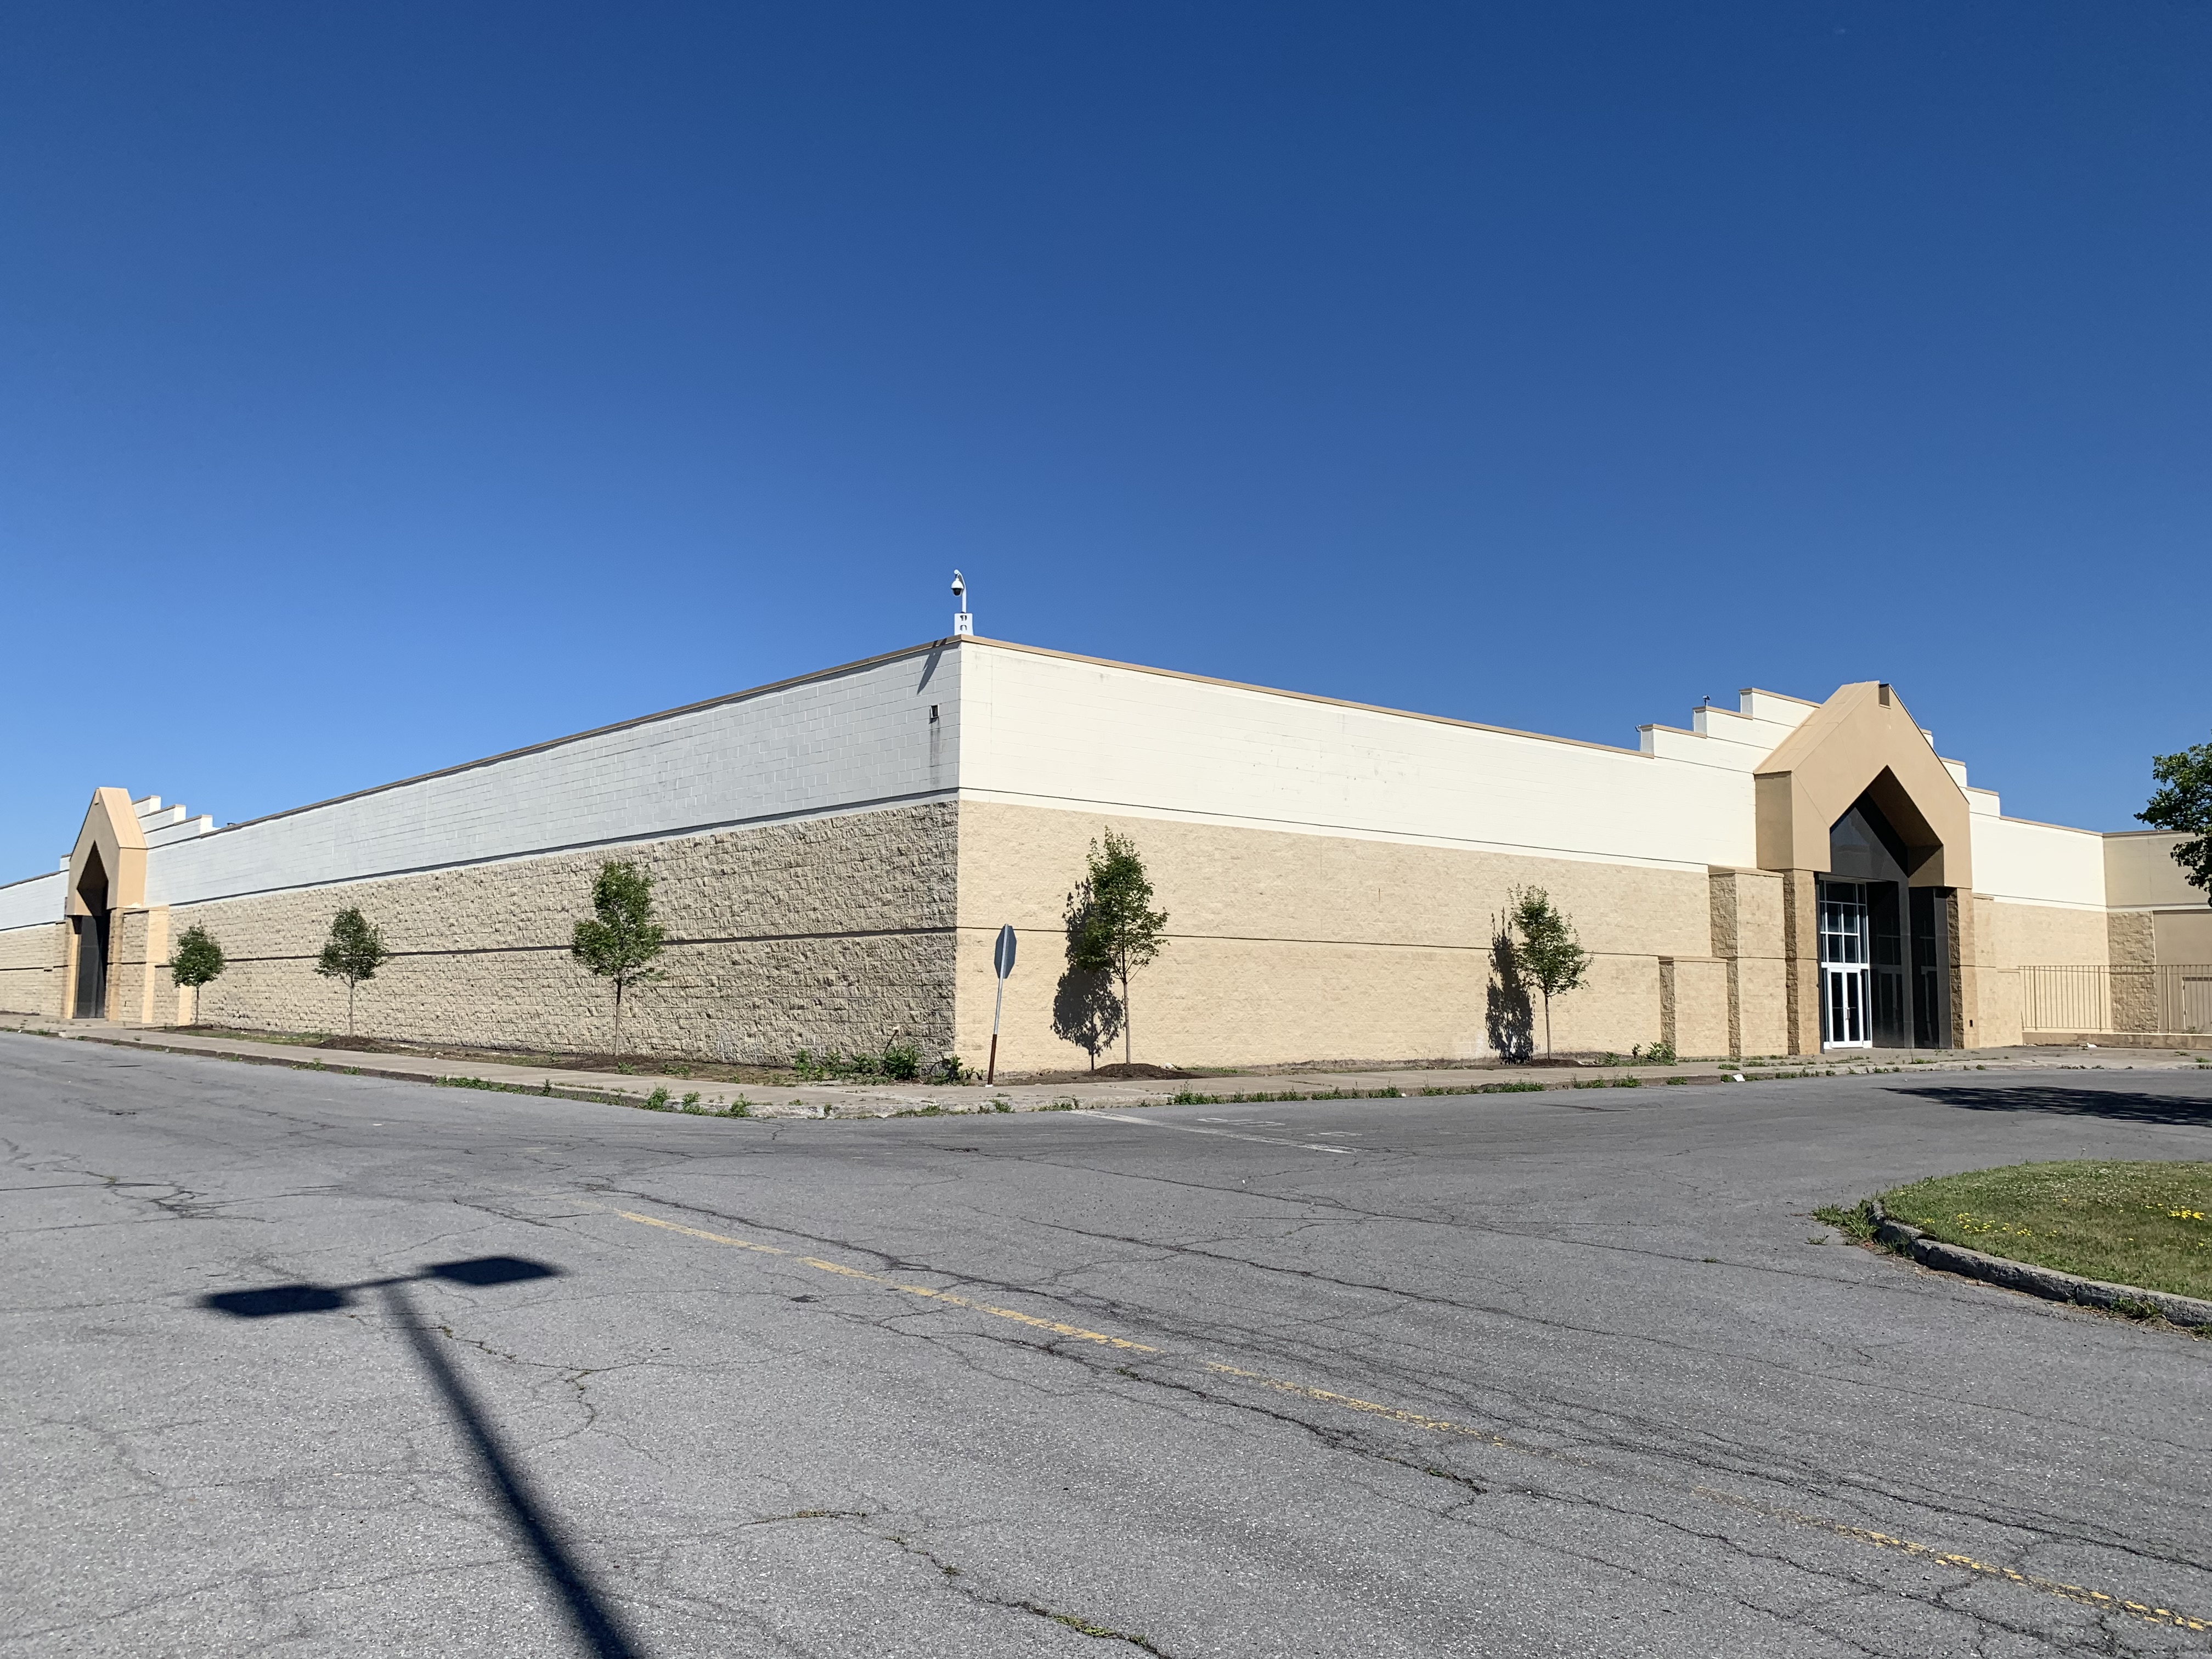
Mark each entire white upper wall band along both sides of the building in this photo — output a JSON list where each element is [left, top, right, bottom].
[[0, 639, 2159, 927]]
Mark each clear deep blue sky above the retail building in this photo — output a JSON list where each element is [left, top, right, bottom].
[[0, 0, 2212, 878]]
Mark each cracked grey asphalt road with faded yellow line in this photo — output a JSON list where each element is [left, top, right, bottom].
[[13, 1035, 2212, 1659]]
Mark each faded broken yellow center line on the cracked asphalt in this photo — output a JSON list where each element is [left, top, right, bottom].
[[582, 1201, 2212, 1633]]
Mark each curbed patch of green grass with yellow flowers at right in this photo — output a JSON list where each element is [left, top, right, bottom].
[[1876, 1159, 2212, 1299]]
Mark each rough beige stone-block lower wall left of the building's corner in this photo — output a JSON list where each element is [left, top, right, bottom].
[[154, 801, 958, 1059]]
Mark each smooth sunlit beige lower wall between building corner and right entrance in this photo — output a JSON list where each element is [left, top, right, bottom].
[[958, 801, 1725, 1070]]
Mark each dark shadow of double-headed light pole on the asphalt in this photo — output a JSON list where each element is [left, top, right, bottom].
[[199, 1256, 639, 1659]]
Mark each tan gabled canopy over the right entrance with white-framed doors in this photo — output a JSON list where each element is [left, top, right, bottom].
[[1756, 679, 1973, 891]]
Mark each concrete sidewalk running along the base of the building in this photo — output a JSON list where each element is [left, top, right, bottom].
[[0, 1015, 2203, 1117]]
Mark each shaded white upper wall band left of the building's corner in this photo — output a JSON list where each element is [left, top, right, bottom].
[[143, 650, 960, 916]]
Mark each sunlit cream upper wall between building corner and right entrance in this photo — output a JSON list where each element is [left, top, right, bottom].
[[960, 644, 1756, 867]]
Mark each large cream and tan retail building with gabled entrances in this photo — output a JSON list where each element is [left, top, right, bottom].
[[0, 637, 2212, 1070]]
